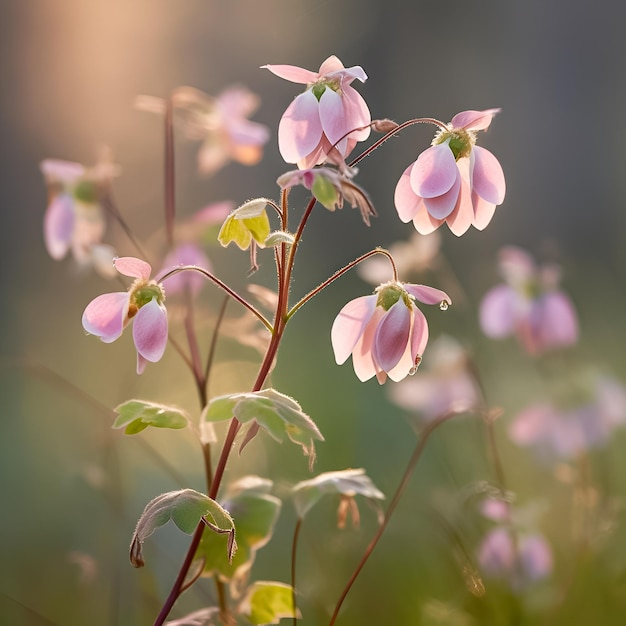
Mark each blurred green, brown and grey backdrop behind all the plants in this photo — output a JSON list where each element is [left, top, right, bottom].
[[0, 0, 626, 626]]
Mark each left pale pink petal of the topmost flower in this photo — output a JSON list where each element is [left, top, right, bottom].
[[278, 89, 322, 163]]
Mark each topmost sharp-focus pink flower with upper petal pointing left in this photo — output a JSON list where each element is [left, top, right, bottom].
[[263, 56, 371, 168]]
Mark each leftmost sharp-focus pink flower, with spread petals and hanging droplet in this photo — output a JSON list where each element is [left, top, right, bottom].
[[83, 257, 167, 374]]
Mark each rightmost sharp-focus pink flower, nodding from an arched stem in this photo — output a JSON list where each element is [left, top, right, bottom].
[[395, 109, 506, 236]]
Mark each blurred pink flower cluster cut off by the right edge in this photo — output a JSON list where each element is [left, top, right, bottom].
[[509, 377, 626, 461]]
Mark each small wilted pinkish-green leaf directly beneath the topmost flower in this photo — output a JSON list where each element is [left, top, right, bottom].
[[276, 167, 376, 226]]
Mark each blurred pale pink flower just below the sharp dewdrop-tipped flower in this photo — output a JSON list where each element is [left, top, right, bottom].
[[389, 336, 481, 421]]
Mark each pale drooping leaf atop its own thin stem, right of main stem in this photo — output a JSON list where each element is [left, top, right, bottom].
[[291, 469, 385, 518]]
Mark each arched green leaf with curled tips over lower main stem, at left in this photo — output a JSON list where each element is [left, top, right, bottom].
[[130, 489, 237, 567]]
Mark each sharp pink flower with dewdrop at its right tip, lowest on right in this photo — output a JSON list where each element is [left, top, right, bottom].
[[331, 281, 451, 385]]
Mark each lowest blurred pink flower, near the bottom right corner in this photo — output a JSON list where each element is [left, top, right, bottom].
[[478, 526, 553, 591]]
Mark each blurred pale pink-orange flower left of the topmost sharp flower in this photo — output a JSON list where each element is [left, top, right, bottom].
[[135, 85, 269, 175]]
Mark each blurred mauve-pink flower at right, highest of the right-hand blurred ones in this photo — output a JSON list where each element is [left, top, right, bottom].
[[480, 247, 578, 355]]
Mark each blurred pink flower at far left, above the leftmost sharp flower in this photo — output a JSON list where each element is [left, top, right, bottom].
[[40, 154, 117, 277]]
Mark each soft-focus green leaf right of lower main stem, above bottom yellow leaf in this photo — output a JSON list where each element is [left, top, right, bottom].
[[195, 476, 282, 581]]
